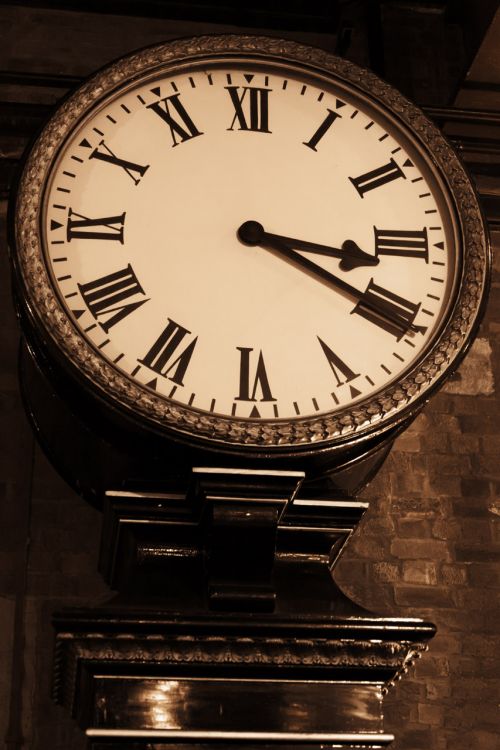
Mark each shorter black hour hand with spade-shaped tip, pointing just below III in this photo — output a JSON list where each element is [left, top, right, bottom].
[[238, 221, 379, 271]]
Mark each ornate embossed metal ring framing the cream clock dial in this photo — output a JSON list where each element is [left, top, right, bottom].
[[15, 35, 490, 453]]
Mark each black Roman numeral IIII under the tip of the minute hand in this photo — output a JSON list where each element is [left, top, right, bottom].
[[352, 279, 427, 341]]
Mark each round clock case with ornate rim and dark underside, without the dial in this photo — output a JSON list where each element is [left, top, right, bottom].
[[9, 35, 490, 506]]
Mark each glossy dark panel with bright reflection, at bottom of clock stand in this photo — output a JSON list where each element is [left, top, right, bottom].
[[91, 675, 382, 742]]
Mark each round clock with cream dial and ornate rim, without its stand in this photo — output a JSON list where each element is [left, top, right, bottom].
[[13, 35, 490, 470]]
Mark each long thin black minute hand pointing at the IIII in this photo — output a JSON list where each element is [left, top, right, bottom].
[[238, 222, 425, 338]]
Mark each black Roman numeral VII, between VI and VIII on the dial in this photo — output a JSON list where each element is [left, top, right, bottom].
[[139, 318, 198, 385]]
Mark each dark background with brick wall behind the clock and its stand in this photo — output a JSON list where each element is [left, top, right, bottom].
[[0, 0, 500, 750]]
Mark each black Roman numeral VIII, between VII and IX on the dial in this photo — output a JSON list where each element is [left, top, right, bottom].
[[78, 263, 148, 333]]
